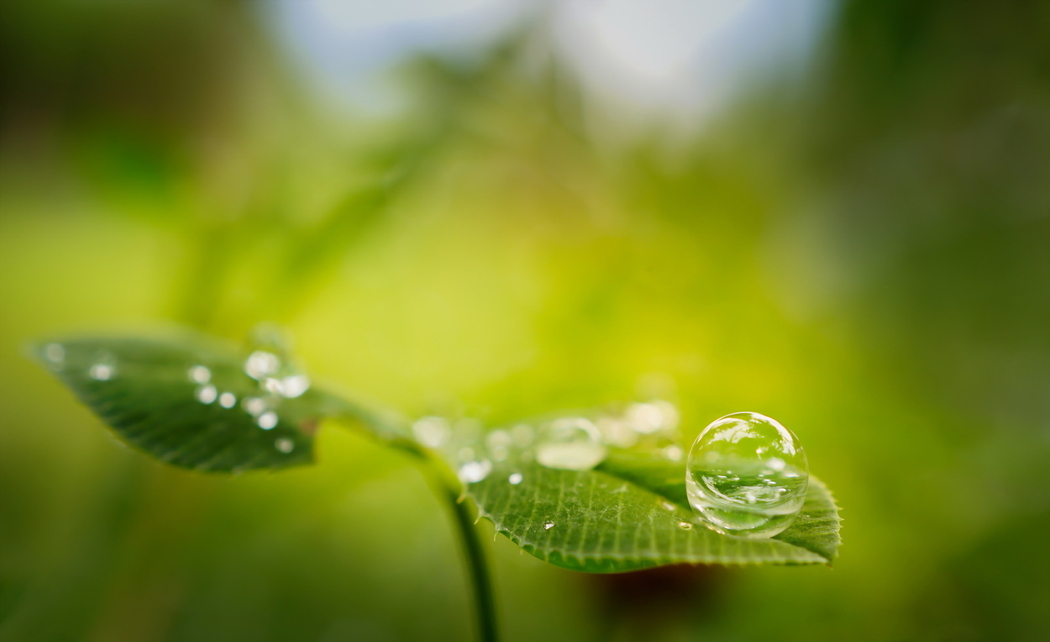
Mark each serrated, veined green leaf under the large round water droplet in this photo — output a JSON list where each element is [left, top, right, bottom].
[[455, 441, 839, 573]]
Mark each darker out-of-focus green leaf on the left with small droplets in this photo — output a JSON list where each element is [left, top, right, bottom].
[[35, 335, 342, 472]]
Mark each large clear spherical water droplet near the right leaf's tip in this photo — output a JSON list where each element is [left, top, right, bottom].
[[686, 412, 810, 538]]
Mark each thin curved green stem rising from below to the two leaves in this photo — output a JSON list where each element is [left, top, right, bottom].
[[424, 457, 499, 642]]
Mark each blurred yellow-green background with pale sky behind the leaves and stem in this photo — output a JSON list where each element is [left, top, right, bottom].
[[0, 0, 1050, 642]]
